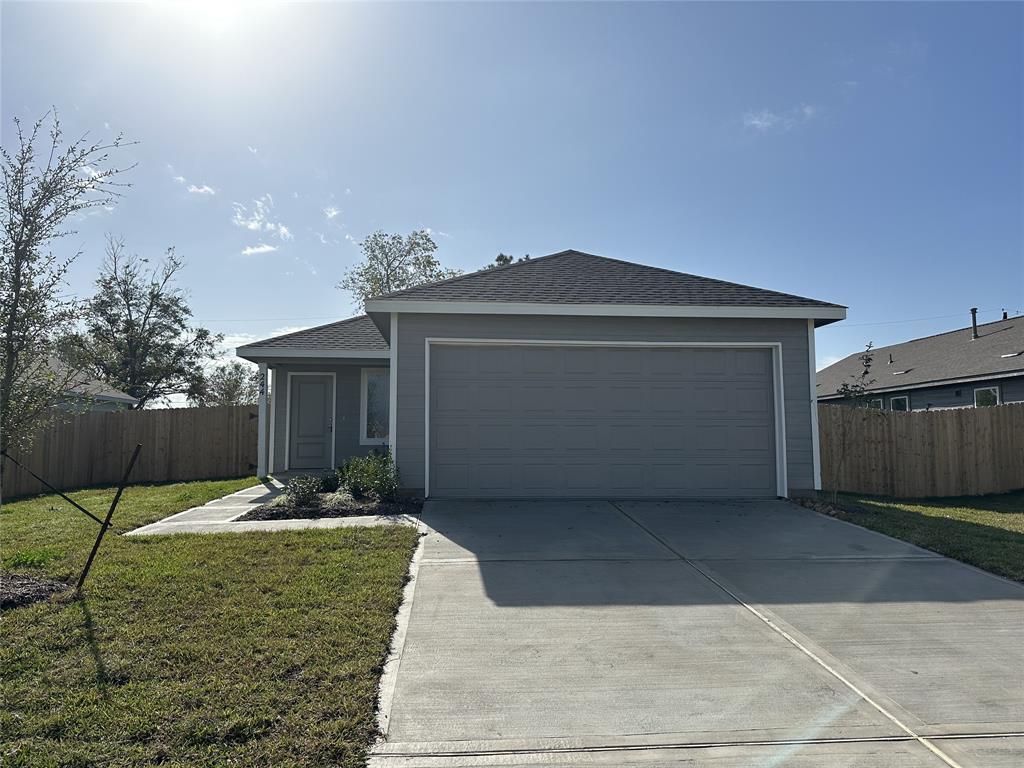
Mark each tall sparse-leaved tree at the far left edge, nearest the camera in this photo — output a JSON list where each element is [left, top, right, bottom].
[[0, 113, 131, 466]]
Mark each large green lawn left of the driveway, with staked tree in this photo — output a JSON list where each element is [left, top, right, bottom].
[[0, 478, 418, 767]]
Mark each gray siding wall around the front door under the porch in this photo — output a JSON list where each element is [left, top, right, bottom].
[[270, 359, 388, 472]]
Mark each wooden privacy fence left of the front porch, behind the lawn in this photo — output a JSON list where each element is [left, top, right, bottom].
[[3, 406, 258, 499]]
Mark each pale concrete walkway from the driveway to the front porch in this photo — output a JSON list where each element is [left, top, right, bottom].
[[125, 478, 420, 536]]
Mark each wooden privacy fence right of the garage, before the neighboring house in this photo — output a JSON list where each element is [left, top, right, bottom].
[[818, 403, 1024, 498]]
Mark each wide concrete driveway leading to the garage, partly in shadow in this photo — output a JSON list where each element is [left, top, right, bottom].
[[372, 501, 1024, 768]]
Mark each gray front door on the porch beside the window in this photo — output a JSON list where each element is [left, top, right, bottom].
[[288, 374, 334, 469]]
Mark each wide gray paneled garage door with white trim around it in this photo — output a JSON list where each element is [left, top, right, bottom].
[[429, 344, 776, 498]]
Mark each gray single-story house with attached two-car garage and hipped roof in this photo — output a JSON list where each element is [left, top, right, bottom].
[[238, 251, 846, 498]]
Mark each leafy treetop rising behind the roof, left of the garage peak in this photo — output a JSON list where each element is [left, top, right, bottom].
[[337, 229, 462, 308]]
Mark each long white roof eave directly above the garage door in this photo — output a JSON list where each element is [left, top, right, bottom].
[[367, 298, 846, 326]]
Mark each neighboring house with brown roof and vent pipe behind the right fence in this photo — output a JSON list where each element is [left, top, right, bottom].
[[817, 313, 1024, 411]]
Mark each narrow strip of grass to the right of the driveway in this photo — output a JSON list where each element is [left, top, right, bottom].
[[836, 490, 1024, 582]]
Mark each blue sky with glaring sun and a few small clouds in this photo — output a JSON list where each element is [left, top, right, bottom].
[[0, 2, 1024, 365]]
